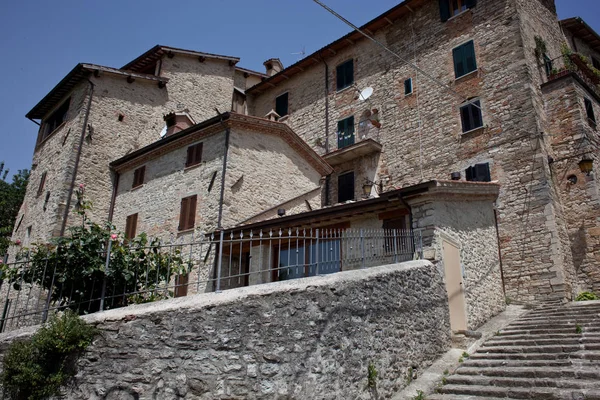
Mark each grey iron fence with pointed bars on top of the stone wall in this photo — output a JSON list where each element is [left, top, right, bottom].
[[0, 228, 423, 332]]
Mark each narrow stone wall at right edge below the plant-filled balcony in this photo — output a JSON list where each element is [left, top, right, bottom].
[[543, 75, 600, 295]]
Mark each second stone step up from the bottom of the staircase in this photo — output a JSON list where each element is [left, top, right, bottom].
[[446, 375, 600, 390]]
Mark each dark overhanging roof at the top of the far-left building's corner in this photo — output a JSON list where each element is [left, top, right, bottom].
[[25, 63, 169, 119]]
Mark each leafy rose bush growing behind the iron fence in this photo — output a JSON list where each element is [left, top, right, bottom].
[[3, 186, 188, 314]]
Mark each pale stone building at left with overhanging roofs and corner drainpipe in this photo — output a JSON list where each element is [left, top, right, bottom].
[[13, 46, 266, 244]]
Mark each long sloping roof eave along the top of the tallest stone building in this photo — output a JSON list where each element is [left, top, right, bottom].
[[247, 0, 427, 94]]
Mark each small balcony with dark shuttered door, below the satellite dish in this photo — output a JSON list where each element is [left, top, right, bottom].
[[323, 120, 383, 166]]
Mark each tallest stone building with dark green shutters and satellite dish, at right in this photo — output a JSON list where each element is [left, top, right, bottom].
[[246, 0, 600, 301]]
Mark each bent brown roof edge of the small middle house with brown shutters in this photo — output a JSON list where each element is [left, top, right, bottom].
[[110, 112, 333, 176]]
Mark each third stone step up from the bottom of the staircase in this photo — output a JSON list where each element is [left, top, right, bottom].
[[455, 367, 600, 381]]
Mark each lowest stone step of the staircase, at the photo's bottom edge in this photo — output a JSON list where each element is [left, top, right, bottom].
[[440, 385, 600, 400]]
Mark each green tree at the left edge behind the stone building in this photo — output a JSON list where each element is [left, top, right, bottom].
[[0, 162, 29, 258]]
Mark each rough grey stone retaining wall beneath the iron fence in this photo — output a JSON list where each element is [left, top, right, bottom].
[[0, 261, 450, 400]]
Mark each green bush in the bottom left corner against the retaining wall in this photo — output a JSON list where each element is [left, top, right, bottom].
[[1, 311, 97, 400]]
